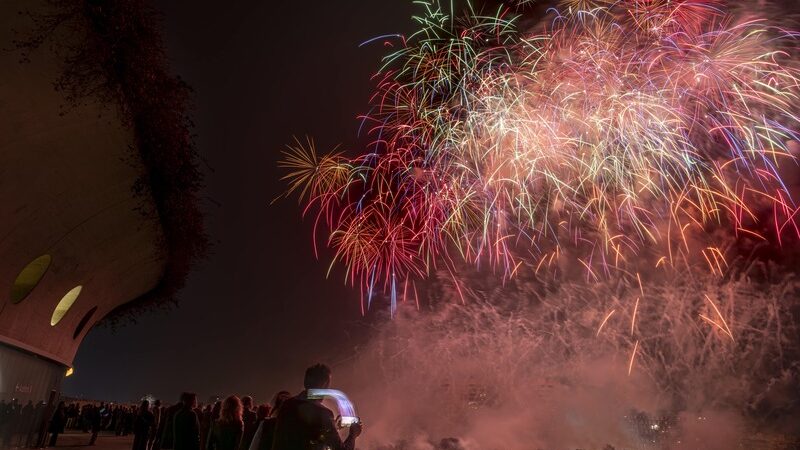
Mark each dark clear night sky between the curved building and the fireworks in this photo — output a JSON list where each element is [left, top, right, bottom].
[[64, 0, 418, 402]]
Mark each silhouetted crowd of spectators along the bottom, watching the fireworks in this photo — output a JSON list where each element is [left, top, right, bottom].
[[0, 364, 362, 450]]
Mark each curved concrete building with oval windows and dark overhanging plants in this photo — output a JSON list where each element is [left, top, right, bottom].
[[0, 0, 206, 403]]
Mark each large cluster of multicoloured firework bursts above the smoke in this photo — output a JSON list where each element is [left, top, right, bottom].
[[281, 0, 800, 314]]
